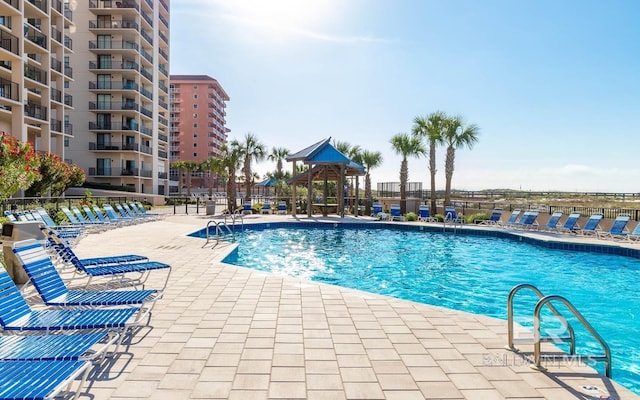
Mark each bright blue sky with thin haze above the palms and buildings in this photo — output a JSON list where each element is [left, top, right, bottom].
[[170, 0, 640, 192]]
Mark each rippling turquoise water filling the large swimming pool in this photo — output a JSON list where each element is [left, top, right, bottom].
[[211, 225, 640, 393]]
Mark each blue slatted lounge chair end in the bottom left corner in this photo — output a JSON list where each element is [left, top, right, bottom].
[[0, 360, 92, 400]]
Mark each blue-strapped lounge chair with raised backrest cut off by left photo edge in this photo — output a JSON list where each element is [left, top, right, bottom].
[[0, 268, 138, 337]]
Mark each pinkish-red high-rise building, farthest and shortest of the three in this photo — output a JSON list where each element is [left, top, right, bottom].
[[169, 75, 229, 191]]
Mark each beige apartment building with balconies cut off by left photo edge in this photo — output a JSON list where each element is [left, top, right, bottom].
[[0, 0, 73, 159]]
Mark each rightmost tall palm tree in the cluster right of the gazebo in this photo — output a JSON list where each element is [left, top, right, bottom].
[[443, 116, 480, 205]]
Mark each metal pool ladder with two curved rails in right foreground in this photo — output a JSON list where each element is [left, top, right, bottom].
[[506, 283, 611, 378]]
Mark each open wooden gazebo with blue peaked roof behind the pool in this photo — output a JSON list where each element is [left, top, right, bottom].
[[286, 137, 365, 218]]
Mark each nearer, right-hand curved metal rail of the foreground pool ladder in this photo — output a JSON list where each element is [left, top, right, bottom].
[[532, 295, 611, 378]]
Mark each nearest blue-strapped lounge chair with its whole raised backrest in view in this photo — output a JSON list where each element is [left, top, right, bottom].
[[13, 239, 160, 320]]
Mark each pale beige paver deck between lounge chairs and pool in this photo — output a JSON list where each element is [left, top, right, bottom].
[[63, 216, 638, 400]]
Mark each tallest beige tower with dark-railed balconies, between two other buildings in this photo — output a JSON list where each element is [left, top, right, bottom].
[[66, 0, 169, 195]]
